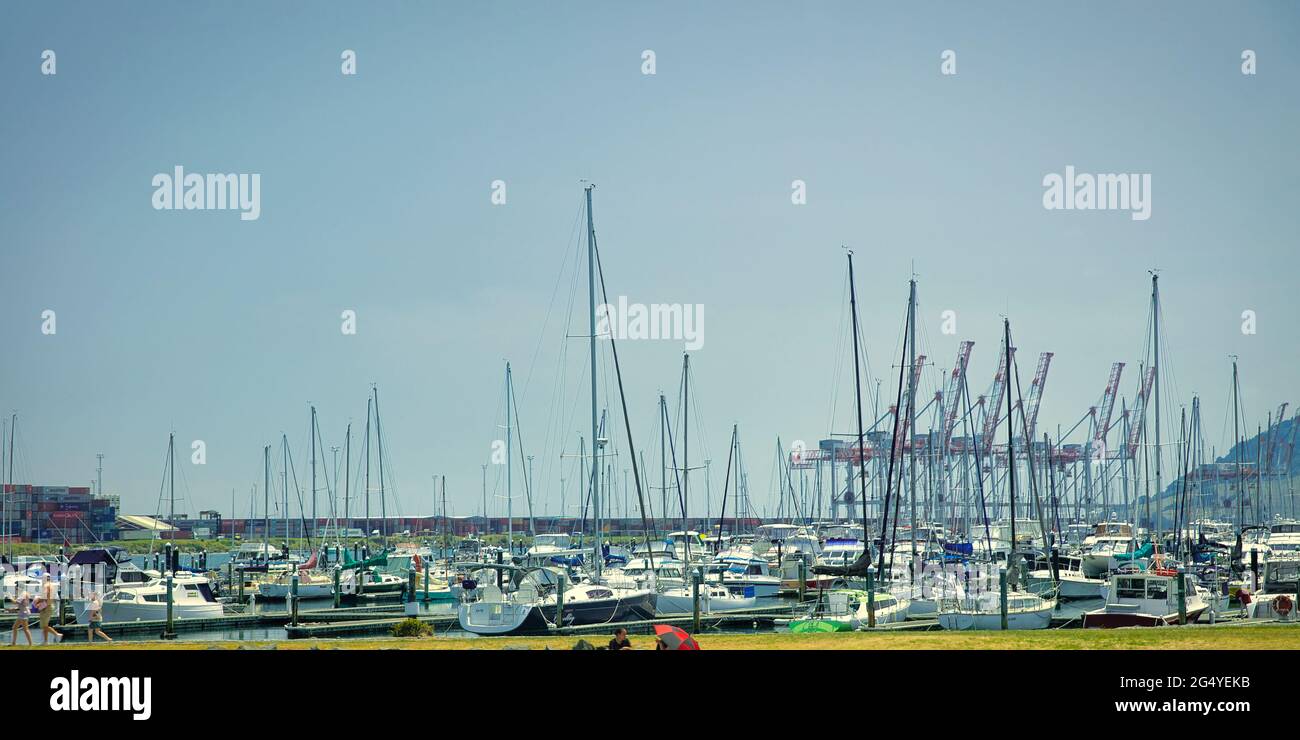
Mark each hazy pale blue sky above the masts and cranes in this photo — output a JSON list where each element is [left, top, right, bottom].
[[0, 1, 1300, 515]]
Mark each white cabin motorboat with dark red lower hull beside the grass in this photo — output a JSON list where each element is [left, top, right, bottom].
[[1083, 568, 1209, 627]]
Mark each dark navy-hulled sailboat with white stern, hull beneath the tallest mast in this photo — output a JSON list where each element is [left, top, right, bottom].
[[456, 563, 658, 635]]
